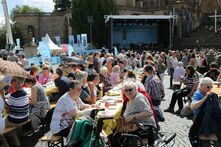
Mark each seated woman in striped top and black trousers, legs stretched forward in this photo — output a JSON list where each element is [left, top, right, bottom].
[[164, 65, 199, 115]]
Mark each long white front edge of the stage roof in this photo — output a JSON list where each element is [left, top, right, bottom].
[[105, 15, 173, 23]]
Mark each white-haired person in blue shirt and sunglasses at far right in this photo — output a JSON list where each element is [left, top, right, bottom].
[[190, 77, 213, 120]]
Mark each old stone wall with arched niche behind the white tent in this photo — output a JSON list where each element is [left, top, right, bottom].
[[15, 13, 71, 46]]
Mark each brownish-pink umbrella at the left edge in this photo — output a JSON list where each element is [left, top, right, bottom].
[[0, 58, 29, 78]]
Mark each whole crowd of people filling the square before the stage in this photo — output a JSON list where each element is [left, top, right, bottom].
[[0, 49, 221, 146]]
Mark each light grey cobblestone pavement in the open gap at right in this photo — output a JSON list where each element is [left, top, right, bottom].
[[160, 75, 192, 147]]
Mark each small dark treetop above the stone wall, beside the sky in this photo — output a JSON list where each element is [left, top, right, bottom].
[[53, 0, 71, 12]]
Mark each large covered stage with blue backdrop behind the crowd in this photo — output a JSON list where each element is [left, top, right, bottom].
[[105, 15, 173, 48]]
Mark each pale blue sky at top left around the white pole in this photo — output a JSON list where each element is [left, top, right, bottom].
[[0, 0, 54, 25]]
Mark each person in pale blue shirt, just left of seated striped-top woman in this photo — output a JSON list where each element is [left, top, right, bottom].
[[173, 62, 185, 89]]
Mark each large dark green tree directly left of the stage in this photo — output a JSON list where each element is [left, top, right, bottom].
[[70, 0, 116, 47]]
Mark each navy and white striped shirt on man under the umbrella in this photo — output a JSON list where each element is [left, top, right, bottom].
[[6, 90, 29, 123]]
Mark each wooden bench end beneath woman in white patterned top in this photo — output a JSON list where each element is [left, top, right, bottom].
[[40, 134, 64, 147]]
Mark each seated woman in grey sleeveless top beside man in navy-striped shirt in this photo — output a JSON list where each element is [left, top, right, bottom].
[[25, 78, 50, 130]]
